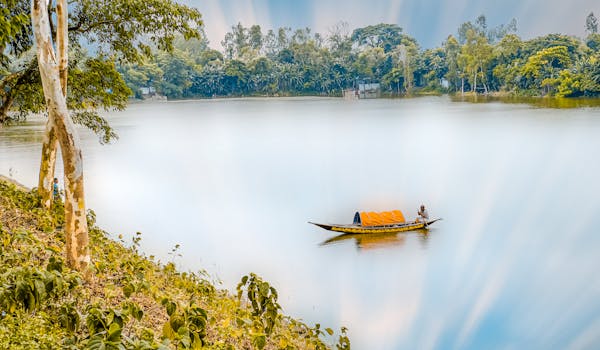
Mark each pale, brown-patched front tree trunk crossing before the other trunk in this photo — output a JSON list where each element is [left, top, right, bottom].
[[31, 0, 90, 274]]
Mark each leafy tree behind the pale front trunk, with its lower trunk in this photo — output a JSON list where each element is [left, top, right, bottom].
[[0, 0, 202, 206]]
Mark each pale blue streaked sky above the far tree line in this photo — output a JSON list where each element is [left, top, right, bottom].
[[181, 0, 600, 49]]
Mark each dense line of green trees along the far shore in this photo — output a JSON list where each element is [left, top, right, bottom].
[[118, 13, 600, 98]]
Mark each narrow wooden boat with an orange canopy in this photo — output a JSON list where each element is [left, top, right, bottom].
[[308, 210, 441, 233]]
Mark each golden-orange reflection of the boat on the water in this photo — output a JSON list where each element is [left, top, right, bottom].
[[320, 230, 430, 250]]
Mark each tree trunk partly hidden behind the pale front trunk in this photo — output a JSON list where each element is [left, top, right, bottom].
[[38, 0, 69, 209]]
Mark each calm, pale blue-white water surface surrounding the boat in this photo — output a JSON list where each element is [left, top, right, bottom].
[[0, 97, 600, 349]]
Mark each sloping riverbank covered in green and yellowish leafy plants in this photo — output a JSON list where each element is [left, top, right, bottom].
[[0, 177, 349, 349]]
